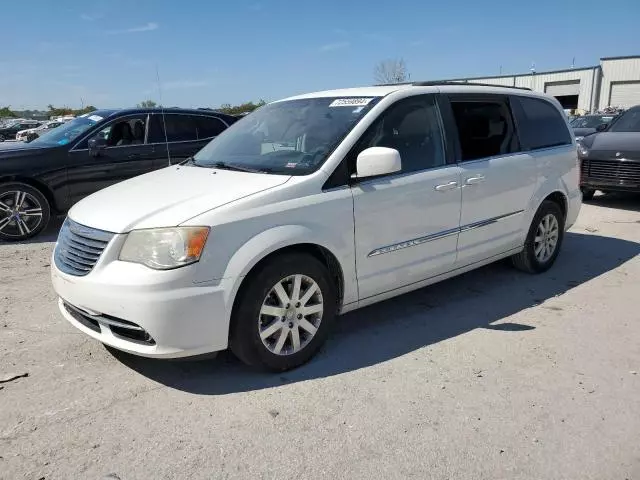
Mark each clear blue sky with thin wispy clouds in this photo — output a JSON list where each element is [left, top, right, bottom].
[[0, 0, 640, 109]]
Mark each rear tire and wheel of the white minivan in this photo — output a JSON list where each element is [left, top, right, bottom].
[[511, 200, 565, 273]]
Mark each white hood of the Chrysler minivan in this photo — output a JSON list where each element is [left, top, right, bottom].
[[69, 166, 291, 233]]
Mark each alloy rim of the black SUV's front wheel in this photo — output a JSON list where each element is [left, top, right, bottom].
[[0, 190, 43, 238]]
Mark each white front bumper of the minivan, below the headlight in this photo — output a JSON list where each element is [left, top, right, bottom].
[[51, 236, 233, 358]]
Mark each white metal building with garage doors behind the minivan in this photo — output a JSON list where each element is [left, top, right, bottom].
[[440, 55, 640, 112]]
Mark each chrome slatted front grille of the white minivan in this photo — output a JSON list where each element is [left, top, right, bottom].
[[54, 218, 114, 277]]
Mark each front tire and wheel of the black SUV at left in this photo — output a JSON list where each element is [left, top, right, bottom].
[[0, 182, 51, 242]]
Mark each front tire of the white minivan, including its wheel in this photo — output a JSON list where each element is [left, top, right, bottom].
[[229, 253, 338, 372]]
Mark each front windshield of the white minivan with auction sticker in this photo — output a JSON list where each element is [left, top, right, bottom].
[[193, 97, 379, 175]]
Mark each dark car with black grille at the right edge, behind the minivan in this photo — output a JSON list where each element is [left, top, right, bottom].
[[578, 105, 640, 200]]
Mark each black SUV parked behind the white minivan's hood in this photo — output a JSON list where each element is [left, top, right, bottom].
[[0, 108, 238, 240]]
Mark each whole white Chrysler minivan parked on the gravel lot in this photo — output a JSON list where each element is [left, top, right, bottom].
[[51, 83, 582, 371]]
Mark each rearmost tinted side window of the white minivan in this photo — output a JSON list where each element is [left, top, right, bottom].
[[511, 97, 571, 150]]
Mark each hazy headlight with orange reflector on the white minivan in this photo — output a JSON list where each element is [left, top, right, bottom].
[[120, 227, 209, 270]]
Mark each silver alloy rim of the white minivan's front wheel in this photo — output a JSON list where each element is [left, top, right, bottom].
[[258, 275, 324, 355]]
